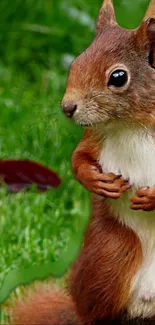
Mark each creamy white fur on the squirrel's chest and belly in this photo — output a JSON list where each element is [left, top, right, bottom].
[[99, 127, 155, 317]]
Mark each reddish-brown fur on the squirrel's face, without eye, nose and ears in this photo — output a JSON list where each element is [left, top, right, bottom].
[[63, 24, 155, 126]]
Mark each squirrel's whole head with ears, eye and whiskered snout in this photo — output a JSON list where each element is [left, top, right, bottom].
[[62, 0, 155, 126]]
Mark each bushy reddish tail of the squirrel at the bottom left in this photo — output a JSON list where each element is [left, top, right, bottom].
[[9, 286, 80, 325]]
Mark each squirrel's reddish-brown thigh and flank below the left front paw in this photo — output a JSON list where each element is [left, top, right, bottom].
[[70, 198, 142, 325]]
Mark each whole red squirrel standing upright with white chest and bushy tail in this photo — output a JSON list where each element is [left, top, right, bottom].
[[10, 0, 155, 325]]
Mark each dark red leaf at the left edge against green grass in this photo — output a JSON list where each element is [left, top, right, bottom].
[[0, 160, 61, 192]]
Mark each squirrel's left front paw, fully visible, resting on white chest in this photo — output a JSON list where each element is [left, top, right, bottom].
[[86, 166, 130, 199]]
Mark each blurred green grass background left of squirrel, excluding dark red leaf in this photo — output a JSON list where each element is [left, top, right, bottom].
[[0, 0, 102, 321]]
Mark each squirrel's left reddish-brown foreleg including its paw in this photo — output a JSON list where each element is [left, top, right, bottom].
[[72, 129, 128, 198]]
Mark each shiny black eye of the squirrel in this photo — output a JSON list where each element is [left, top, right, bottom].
[[108, 70, 128, 88]]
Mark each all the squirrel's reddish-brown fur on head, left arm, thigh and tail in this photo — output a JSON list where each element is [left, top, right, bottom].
[[11, 0, 155, 325]]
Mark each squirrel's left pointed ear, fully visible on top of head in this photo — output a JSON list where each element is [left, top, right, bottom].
[[96, 0, 117, 36]]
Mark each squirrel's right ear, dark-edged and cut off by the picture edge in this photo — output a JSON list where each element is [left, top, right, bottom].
[[136, 18, 155, 68]]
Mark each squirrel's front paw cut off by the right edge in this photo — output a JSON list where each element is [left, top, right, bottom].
[[131, 187, 155, 211]]
